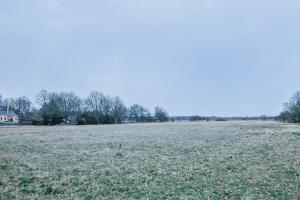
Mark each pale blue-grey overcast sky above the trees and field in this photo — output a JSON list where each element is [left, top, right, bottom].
[[0, 0, 300, 116]]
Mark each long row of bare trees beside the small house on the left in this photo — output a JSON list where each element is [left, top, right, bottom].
[[0, 90, 169, 125]]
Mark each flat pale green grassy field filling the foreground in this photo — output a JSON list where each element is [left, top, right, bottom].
[[0, 122, 300, 199]]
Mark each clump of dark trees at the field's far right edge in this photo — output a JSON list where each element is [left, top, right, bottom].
[[277, 91, 300, 123]]
